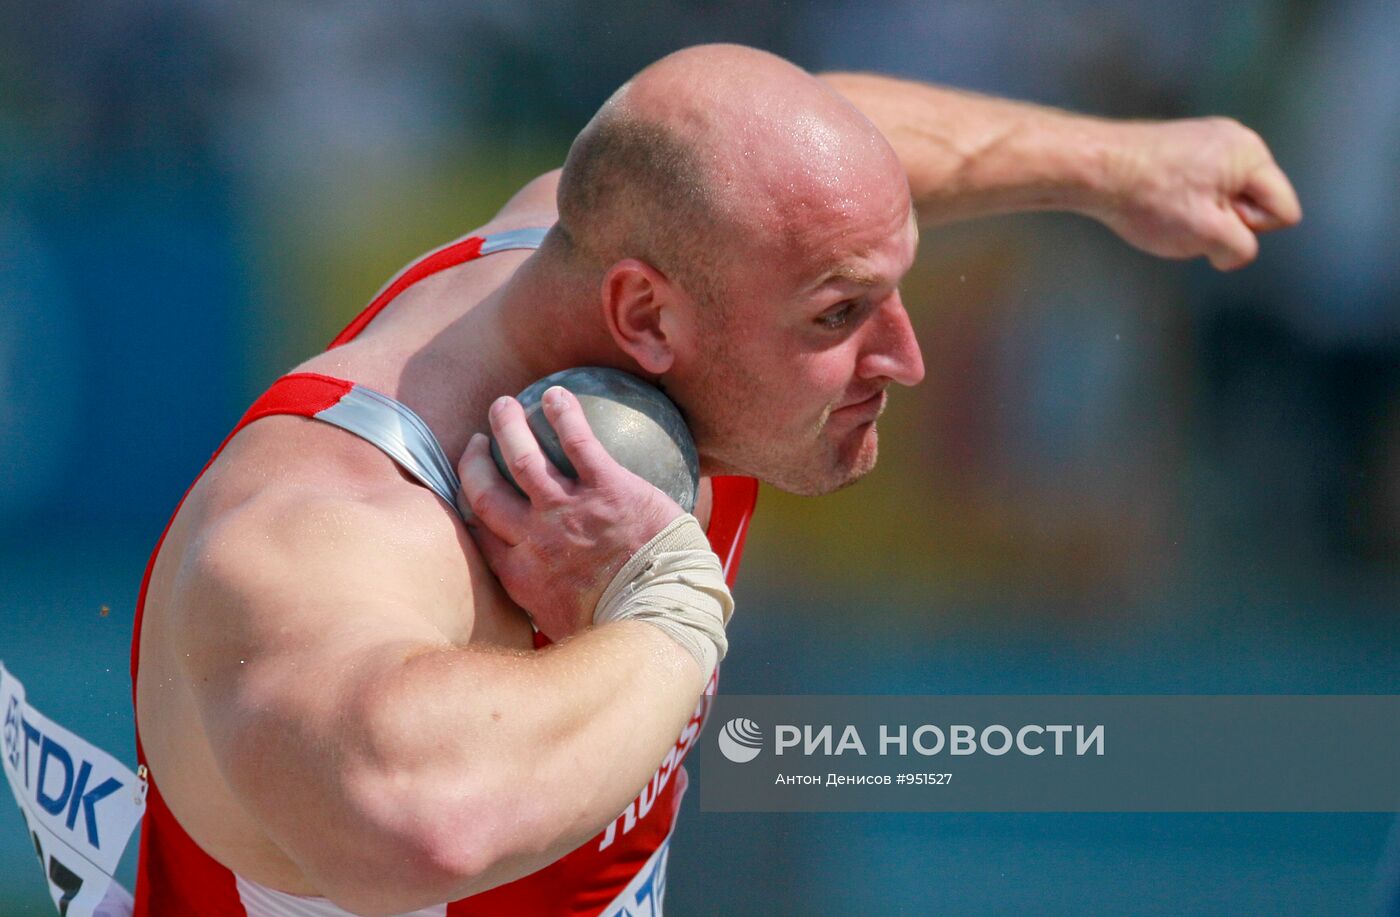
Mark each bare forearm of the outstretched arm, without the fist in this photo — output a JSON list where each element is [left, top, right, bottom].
[[822, 73, 1114, 225]]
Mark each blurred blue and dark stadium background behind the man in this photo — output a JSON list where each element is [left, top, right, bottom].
[[0, 0, 1400, 914]]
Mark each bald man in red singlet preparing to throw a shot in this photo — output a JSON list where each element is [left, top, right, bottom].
[[133, 46, 1299, 916]]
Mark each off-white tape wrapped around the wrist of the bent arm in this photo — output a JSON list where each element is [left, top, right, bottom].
[[594, 512, 734, 682]]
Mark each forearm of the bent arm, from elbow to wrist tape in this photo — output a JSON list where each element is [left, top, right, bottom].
[[372, 622, 704, 897]]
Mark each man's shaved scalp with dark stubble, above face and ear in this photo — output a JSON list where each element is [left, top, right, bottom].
[[559, 45, 903, 302]]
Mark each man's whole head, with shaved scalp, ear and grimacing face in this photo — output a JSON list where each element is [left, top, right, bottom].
[[554, 45, 923, 493]]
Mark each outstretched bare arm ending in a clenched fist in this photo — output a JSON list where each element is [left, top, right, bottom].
[[822, 73, 1302, 270]]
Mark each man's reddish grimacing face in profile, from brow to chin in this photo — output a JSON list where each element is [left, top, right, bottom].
[[672, 184, 924, 494]]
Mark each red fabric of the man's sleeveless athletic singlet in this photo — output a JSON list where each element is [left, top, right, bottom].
[[132, 237, 757, 917]]
